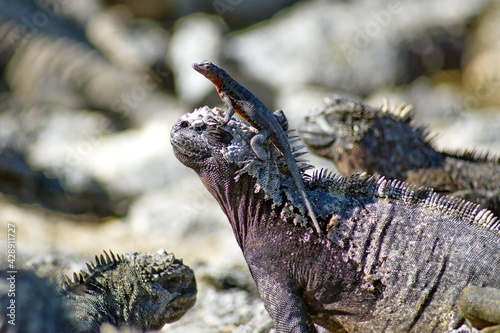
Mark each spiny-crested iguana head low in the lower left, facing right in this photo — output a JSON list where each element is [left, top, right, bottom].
[[64, 249, 197, 330]]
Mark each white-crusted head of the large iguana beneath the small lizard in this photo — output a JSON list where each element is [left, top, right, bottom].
[[170, 106, 318, 230]]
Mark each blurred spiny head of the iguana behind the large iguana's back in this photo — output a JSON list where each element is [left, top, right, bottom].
[[300, 96, 440, 179]]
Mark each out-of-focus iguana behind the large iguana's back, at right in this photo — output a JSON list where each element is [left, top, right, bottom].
[[300, 96, 500, 216]]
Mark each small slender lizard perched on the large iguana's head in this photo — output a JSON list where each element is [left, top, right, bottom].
[[193, 61, 320, 233]]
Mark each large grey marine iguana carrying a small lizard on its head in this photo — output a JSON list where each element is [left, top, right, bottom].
[[171, 107, 500, 333]]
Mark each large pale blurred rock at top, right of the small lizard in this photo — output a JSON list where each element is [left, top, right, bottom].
[[225, 0, 488, 94]]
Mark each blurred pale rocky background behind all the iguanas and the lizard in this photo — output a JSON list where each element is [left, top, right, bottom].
[[0, 0, 500, 332]]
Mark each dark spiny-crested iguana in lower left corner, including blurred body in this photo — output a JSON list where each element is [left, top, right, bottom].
[[0, 250, 197, 332]]
